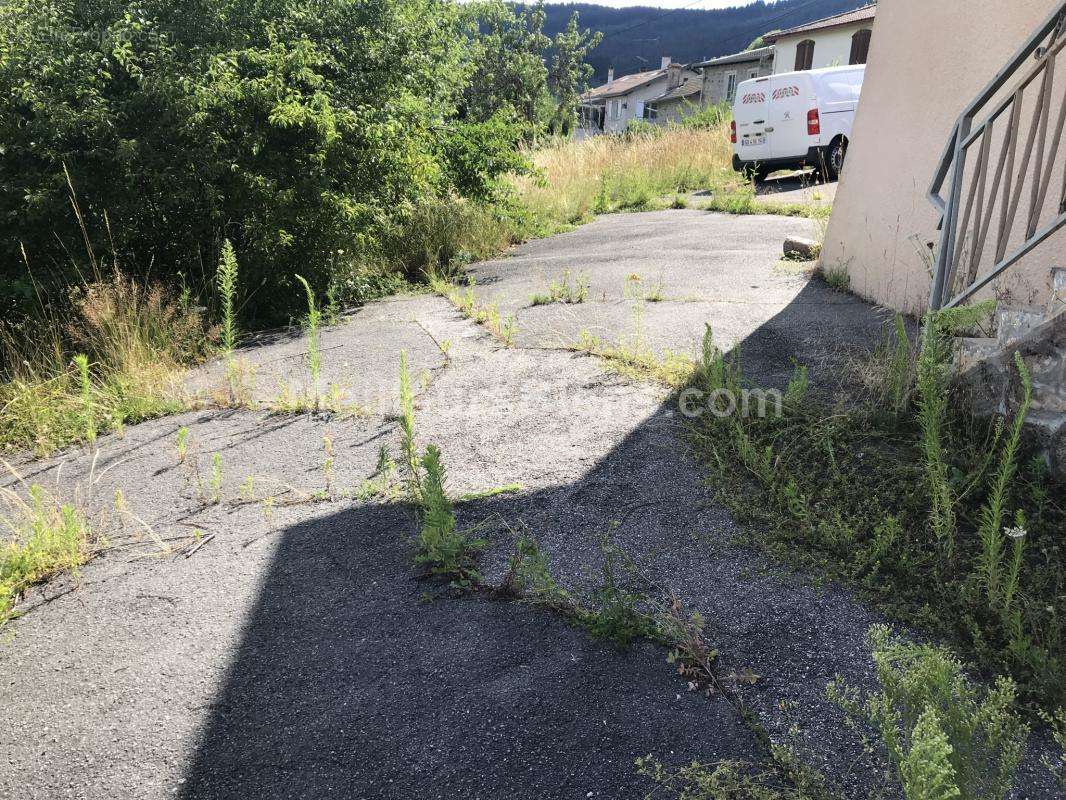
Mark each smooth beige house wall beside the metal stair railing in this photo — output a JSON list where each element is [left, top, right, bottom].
[[822, 0, 1066, 313]]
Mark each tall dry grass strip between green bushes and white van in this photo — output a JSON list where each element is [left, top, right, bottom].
[[514, 121, 750, 231]]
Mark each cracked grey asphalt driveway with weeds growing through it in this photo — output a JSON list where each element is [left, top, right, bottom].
[[0, 211, 1052, 800]]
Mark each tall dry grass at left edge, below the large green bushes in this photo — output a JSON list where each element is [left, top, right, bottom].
[[0, 270, 210, 454]]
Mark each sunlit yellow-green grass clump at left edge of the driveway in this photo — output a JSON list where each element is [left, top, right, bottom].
[[0, 484, 92, 625]]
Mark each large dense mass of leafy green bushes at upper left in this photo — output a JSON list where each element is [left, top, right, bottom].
[[0, 0, 523, 320]]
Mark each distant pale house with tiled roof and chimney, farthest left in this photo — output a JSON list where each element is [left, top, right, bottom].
[[581, 57, 699, 134]]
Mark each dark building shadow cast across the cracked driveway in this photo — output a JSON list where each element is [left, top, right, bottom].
[[180, 282, 881, 800]]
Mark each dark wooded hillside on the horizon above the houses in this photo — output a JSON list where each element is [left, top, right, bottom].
[[545, 0, 869, 85]]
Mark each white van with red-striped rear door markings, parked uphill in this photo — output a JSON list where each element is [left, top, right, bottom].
[[731, 65, 866, 180]]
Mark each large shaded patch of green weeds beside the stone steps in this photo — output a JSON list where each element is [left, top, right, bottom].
[[693, 308, 1066, 708]]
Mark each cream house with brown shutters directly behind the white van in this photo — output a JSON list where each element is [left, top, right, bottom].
[[762, 3, 877, 75]]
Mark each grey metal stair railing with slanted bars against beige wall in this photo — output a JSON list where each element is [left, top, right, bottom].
[[930, 2, 1066, 310]]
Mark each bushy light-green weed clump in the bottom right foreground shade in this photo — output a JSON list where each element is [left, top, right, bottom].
[[828, 626, 1029, 800]]
